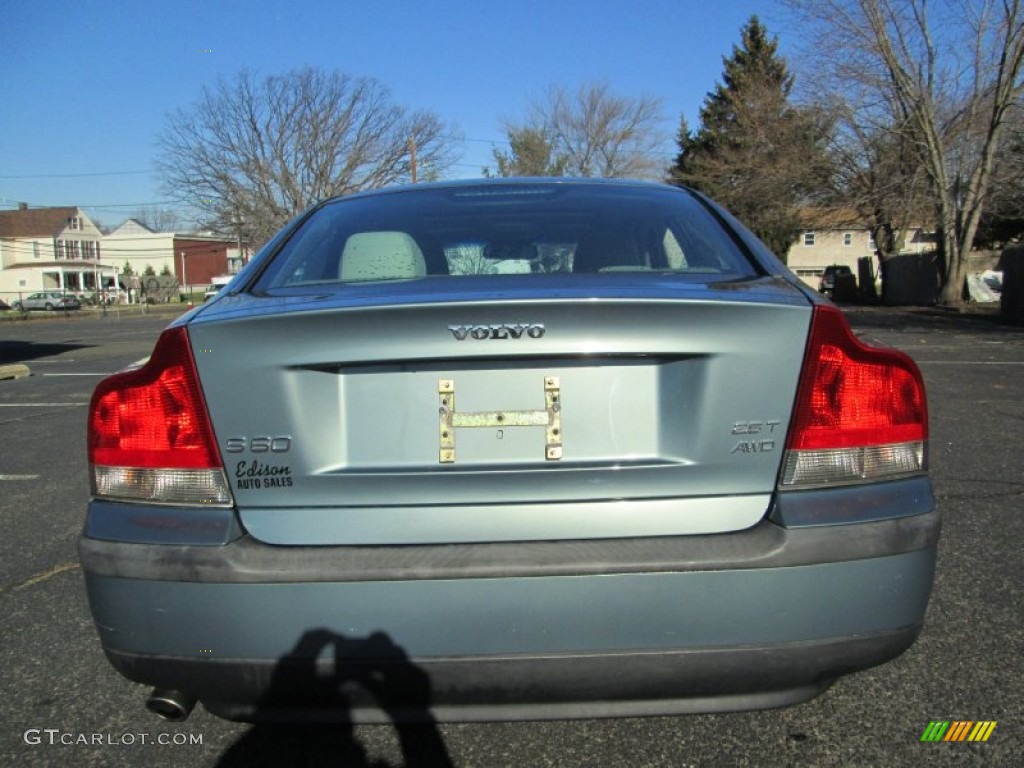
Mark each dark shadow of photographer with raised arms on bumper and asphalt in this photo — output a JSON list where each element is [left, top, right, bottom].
[[217, 629, 452, 768]]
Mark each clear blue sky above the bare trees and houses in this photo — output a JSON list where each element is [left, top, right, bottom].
[[0, 0, 787, 225]]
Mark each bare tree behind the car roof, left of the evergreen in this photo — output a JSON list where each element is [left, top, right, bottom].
[[496, 83, 665, 178]]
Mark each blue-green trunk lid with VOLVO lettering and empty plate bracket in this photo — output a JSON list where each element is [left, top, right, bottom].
[[189, 279, 810, 544]]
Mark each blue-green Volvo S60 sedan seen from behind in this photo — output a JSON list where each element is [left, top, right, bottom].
[[80, 179, 939, 721]]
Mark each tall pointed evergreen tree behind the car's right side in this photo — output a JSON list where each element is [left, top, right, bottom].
[[671, 16, 831, 258]]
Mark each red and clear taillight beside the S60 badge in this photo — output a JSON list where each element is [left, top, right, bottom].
[[89, 328, 229, 504]]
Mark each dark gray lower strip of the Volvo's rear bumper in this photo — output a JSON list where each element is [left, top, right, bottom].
[[106, 627, 920, 723]]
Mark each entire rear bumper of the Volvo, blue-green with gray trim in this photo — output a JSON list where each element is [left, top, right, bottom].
[[80, 481, 939, 722]]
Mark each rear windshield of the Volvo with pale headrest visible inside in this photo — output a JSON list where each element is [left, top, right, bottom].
[[254, 184, 756, 291]]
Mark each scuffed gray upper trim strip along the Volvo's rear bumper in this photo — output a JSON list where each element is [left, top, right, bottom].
[[79, 512, 940, 584]]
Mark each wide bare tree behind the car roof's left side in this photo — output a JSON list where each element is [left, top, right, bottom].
[[158, 68, 456, 244]]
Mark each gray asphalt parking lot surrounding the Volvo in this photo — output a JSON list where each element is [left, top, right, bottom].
[[0, 308, 1024, 768]]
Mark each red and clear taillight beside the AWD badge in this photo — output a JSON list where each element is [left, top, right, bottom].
[[782, 306, 928, 485]]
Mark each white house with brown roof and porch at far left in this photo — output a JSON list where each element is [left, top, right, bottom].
[[0, 203, 118, 304]]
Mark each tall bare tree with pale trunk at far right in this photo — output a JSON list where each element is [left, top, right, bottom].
[[788, 0, 1024, 305]]
